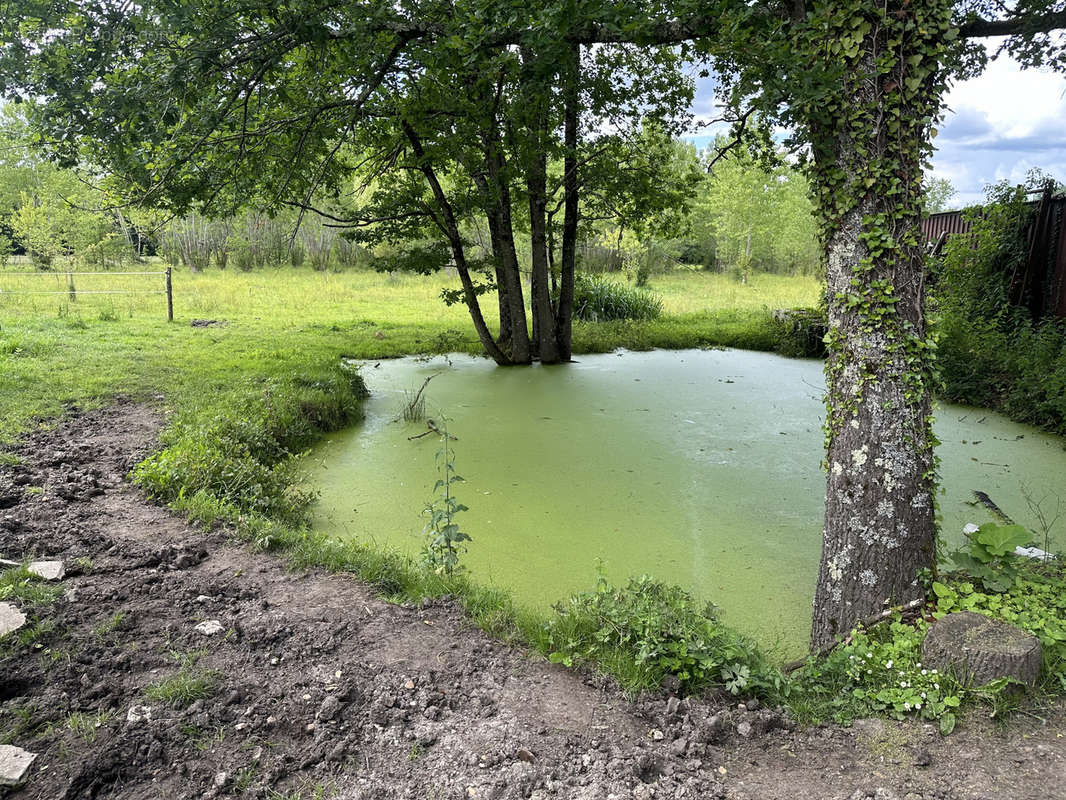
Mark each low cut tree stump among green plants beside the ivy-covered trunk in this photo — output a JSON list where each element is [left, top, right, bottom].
[[922, 611, 1044, 686]]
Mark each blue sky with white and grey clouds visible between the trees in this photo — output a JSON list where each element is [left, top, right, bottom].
[[689, 39, 1066, 208]]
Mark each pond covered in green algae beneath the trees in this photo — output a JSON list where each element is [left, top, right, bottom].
[[307, 350, 1066, 658]]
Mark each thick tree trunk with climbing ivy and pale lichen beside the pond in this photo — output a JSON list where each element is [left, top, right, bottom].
[[807, 3, 950, 650]]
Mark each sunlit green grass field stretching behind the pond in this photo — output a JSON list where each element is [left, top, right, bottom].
[[0, 263, 819, 442]]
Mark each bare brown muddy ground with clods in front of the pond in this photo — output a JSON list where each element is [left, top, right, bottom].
[[0, 404, 1066, 800]]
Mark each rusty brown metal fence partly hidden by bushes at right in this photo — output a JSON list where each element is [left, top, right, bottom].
[[922, 186, 1066, 319]]
